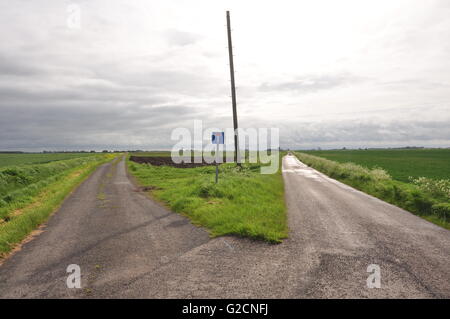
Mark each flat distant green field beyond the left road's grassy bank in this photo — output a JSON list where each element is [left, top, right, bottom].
[[0, 153, 98, 167]]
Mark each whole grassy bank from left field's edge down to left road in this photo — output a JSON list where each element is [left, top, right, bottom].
[[0, 155, 117, 258]]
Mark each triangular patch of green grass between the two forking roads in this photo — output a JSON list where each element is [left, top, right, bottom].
[[128, 157, 287, 243]]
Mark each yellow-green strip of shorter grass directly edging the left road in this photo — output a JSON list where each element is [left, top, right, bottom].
[[0, 155, 115, 259]]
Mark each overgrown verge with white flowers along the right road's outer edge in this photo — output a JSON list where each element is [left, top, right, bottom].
[[295, 152, 450, 229]]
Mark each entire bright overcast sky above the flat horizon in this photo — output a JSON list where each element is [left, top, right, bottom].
[[0, 0, 450, 150]]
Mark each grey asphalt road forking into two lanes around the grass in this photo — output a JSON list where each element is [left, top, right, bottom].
[[0, 156, 450, 298]]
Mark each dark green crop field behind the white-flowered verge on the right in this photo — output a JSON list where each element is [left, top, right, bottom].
[[301, 149, 450, 182]]
